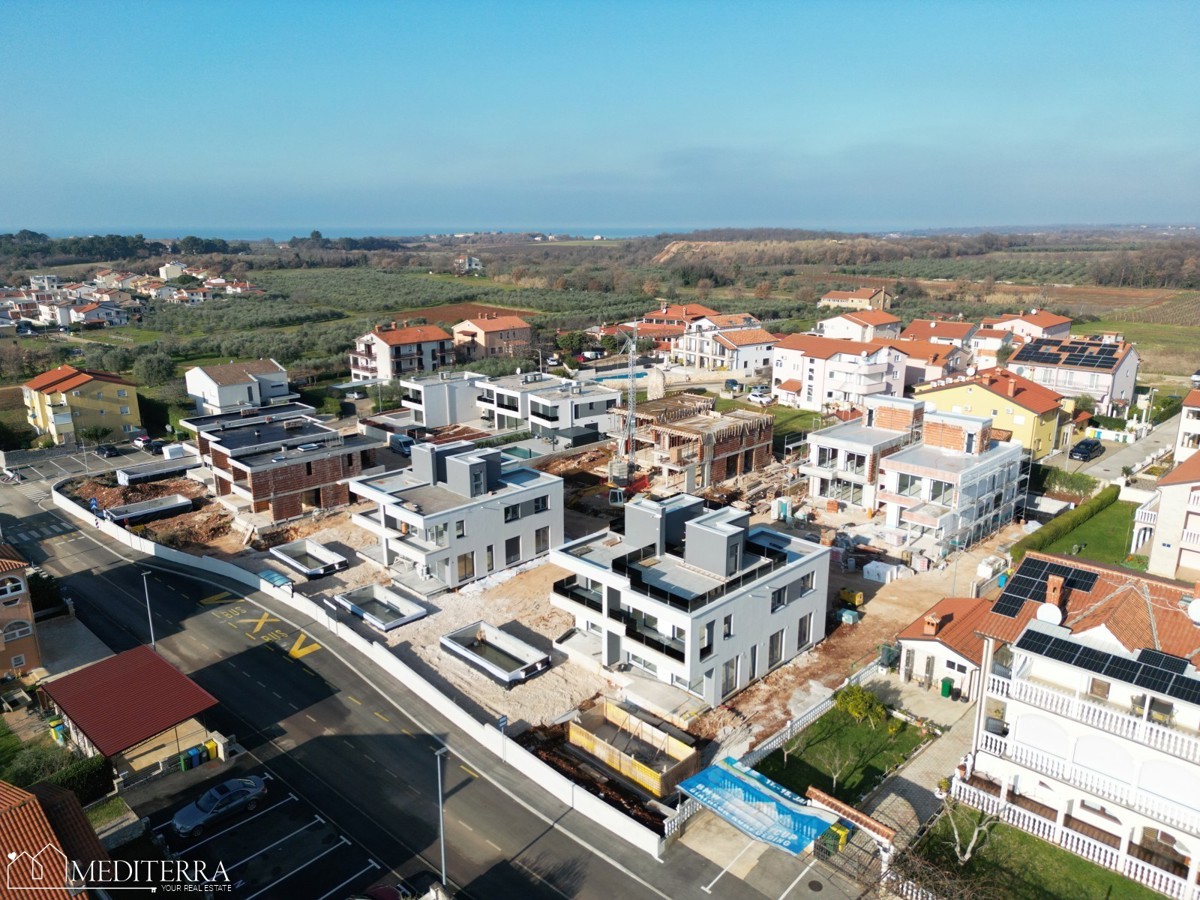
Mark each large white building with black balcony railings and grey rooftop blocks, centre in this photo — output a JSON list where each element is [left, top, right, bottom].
[[551, 494, 829, 706]]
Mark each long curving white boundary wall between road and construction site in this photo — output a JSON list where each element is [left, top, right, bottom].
[[50, 482, 672, 858]]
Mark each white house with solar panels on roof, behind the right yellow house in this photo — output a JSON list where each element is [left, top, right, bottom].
[[1008, 337, 1139, 415]]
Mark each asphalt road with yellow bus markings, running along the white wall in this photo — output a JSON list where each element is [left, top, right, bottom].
[[0, 482, 864, 900]]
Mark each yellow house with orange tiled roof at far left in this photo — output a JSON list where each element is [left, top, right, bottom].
[[22, 366, 142, 444]]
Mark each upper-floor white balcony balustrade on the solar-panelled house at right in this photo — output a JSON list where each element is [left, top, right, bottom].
[[988, 676, 1200, 764]]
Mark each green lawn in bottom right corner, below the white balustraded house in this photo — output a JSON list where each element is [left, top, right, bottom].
[[918, 805, 1160, 900]]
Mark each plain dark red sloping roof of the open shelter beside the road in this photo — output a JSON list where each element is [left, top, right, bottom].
[[43, 647, 217, 756]]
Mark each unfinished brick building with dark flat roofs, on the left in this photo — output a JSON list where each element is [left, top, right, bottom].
[[180, 403, 388, 528]]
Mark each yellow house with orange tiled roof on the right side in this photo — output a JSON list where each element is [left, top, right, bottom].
[[912, 368, 1070, 460]]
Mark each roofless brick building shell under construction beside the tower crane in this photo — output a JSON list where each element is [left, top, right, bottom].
[[613, 394, 775, 493]]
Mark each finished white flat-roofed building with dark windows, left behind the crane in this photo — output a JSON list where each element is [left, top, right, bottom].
[[476, 372, 620, 437]]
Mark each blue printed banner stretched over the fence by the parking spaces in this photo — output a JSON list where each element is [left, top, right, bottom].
[[679, 757, 838, 854]]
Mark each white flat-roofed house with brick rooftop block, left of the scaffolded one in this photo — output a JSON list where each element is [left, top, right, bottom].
[[800, 396, 925, 511]]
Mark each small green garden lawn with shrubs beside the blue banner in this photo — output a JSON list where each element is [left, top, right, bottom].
[[756, 709, 924, 803]]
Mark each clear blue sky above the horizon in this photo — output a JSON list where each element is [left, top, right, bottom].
[[0, 0, 1200, 238]]
